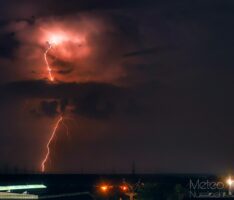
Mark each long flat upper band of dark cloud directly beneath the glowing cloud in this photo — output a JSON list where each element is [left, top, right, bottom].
[[2, 80, 124, 99]]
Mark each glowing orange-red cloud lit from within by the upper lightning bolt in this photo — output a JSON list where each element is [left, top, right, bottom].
[[0, 13, 140, 83]]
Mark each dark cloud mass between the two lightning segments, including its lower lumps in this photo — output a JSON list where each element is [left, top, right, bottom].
[[1, 81, 146, 119]]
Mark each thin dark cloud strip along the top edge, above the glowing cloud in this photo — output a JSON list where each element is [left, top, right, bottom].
[[0, 0, 155, 19]]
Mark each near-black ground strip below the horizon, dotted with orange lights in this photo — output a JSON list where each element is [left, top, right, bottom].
[[0, 174, 230, 200]]
